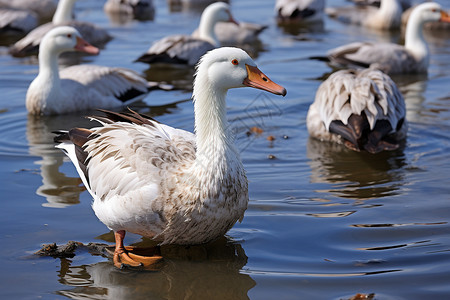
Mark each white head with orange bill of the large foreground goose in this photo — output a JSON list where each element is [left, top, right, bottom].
[[194, 47, 286, 99]]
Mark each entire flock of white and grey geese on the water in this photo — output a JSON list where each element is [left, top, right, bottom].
[[0, 0, 450, 268]]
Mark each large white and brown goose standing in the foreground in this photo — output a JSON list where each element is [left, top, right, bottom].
[[55, 47, 286, 268]]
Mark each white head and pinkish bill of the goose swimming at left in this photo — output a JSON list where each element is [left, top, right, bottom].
[[39, 26, 100, 55]]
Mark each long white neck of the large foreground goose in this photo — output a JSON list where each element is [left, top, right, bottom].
[[193, 73, 234, 167]]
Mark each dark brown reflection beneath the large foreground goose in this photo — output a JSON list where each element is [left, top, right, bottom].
[[57, 237, 256, 299]]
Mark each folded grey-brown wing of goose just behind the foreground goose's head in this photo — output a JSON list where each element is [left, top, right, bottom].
[[136, 35, 214, 66]]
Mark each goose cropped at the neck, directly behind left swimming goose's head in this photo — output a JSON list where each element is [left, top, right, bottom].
[[9, 0, 112, 57]]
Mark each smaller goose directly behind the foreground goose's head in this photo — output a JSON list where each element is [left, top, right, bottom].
[[136, 2, 237, 66]]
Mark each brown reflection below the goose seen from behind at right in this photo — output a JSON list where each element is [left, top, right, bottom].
[[306, 138, 406, 200]]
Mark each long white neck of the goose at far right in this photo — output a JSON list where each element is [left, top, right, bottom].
[[405, 10, 430, 66]]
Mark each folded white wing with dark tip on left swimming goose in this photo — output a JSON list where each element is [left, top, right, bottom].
[[60, 65, 149, 103]]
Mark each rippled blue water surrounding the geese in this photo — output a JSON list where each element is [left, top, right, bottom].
[[0, 0, 450, 299]]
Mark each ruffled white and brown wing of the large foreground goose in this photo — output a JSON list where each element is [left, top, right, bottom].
[[55, 111, 195, 200]]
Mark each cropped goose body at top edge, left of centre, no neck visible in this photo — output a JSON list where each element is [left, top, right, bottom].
[[103, 0, 155, 20]]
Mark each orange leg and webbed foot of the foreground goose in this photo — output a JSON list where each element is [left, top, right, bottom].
[[113, 230, 162, 269]]
